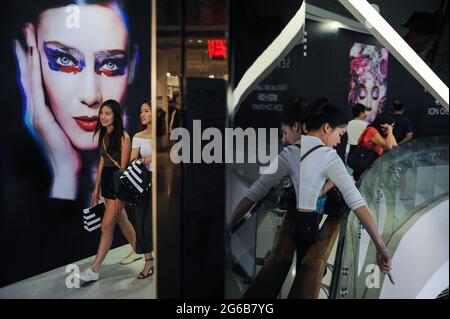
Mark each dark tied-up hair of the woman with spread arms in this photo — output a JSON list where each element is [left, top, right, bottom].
[[302, 97, 348, 132]]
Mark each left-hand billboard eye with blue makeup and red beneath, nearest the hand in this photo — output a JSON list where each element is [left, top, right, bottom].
[[43, 41, 86, 74]]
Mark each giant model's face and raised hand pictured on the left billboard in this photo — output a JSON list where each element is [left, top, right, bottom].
[[13, 2, 138, 200]]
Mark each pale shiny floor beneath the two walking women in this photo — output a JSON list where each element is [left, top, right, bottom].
[[0, 245, 156, 299]]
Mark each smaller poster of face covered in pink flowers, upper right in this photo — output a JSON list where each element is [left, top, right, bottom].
[[348, 43, 388, 122]]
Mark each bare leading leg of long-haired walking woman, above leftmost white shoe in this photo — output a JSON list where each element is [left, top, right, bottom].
[[91, 199, 117, 272]]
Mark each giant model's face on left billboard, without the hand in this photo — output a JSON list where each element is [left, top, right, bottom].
[[37, 5, 131, 150]]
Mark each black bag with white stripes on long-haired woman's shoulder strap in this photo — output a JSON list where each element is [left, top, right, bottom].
[[103, 140, 151, 205]]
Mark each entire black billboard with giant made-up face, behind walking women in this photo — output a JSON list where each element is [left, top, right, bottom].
[[0, 0, 151, 286]]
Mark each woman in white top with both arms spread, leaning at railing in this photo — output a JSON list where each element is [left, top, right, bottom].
[[229, 99, 391, 273]]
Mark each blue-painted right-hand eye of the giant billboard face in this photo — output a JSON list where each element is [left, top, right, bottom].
[[95, 50, 127, 77]]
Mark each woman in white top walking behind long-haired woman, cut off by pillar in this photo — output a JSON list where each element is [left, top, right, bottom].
[[130, 102, 153, 279]]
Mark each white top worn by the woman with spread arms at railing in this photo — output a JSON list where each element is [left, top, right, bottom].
[[245, 135, 366, 211]]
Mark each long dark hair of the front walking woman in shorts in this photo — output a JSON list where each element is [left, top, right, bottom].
[[92, 100, 124, 154]]
